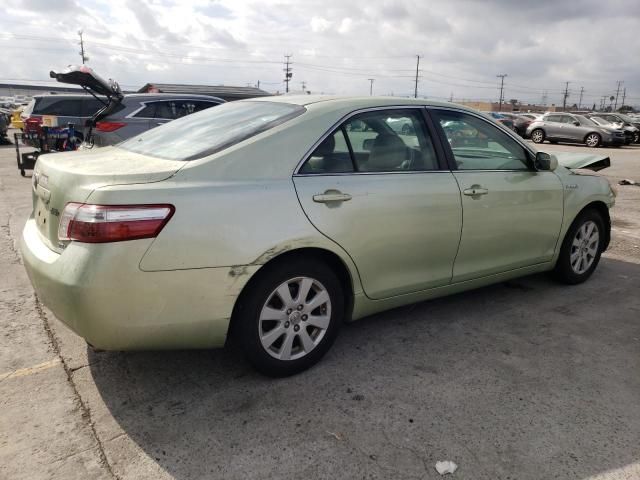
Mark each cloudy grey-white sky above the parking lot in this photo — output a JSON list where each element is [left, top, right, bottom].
[[0, 0, 640, 105]]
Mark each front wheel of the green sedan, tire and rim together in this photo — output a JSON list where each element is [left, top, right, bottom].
[[554, 210, 605, 285]]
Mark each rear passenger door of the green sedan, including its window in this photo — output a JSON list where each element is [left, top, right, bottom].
[[293, 108, 462, 299]]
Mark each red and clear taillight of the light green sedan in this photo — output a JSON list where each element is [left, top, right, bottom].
[[58, 203, 175, 243]]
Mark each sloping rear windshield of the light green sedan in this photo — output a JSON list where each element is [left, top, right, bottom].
[[118, 101, 305, 160]]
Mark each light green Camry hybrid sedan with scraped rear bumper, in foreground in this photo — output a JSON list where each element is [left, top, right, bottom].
[[22, 96, 615, 376]]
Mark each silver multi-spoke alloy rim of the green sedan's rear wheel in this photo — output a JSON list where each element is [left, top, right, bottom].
[[258, 277, 331, 360]]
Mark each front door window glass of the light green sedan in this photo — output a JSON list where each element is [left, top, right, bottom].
[[433, 110, 529, 170]]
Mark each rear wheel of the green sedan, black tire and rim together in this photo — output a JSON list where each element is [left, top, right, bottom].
[[237, 257, 344, 377]]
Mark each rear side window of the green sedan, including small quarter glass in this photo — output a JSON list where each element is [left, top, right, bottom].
[[300, 109, 438, 174]]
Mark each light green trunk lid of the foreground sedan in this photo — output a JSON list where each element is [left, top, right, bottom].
[[32, 147, 185, 252]]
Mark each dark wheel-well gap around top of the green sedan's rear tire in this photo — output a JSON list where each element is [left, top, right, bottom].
[[227, 247, 357, 342]]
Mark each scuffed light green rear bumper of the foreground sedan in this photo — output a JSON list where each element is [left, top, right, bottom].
[[21, 219, 258, 350]]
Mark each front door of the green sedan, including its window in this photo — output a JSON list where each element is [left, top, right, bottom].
[[432, 108, 564, 283]]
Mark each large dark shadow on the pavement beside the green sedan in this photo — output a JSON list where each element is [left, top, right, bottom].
[[89, 259, 640, 480]]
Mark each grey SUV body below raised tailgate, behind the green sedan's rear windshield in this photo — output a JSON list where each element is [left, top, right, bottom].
[[93, 93, 224, 147]]
